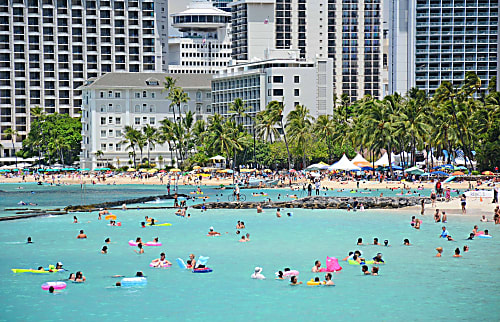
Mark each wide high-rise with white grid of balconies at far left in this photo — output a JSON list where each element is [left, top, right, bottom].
[[0, 0, 168, 156]]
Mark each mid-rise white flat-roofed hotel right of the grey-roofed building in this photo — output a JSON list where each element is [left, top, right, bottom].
[[212, 51, 333, 132]]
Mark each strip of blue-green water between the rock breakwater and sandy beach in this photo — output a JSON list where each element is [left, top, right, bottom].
[[0, 183, 430, 216]]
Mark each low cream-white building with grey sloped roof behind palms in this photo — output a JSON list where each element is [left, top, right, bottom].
[[80, 73, 212, 169]]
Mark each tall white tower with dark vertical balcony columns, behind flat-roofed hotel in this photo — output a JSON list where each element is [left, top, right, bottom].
[[230, 0, 387, 100]]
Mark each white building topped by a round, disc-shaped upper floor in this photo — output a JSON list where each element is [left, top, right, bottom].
[[166, 0, 231, 74]]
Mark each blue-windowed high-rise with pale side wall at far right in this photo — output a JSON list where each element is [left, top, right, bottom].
[[388, 0, 499, 95]]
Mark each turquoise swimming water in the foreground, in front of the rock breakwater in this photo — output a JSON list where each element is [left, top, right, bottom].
[[0, 205, 500, 321]]
